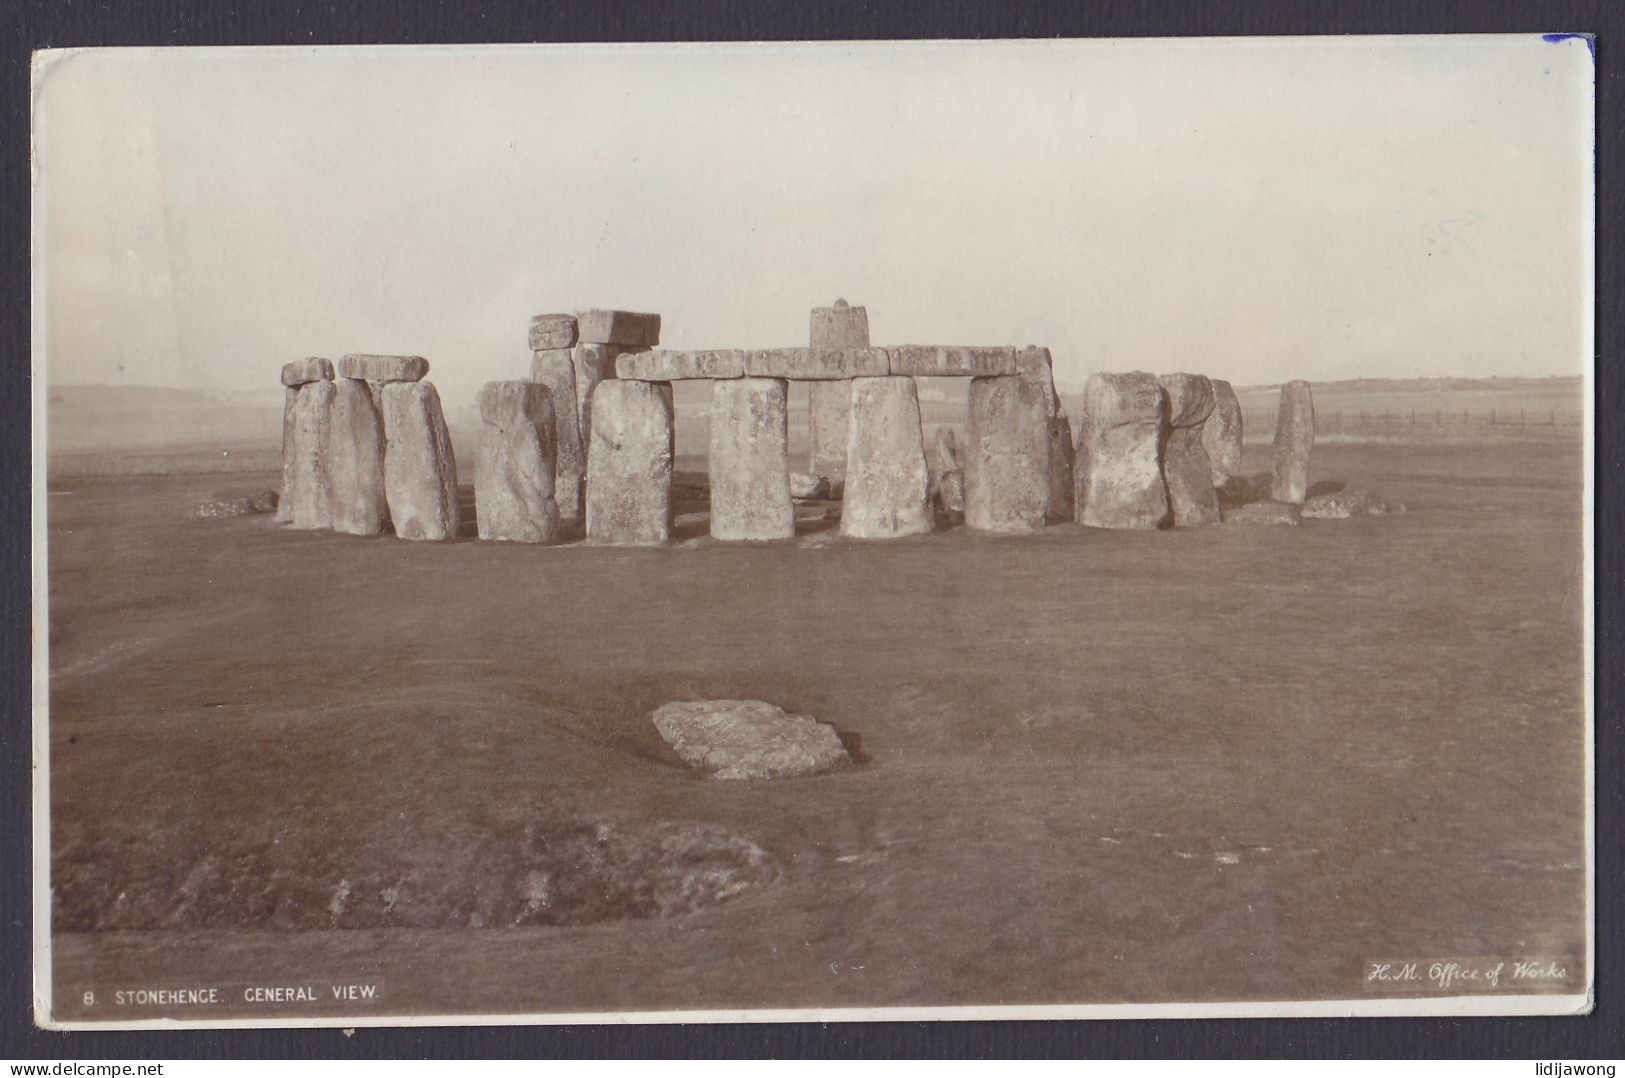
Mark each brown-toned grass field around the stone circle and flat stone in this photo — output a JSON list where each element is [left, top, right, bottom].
[[47, 405, 1586, 1019]]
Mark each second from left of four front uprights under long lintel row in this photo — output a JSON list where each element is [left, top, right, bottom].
[[710, 377, 796, 540]]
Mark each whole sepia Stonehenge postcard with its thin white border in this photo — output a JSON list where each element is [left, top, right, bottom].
[[31, 33, 1596, 1029]]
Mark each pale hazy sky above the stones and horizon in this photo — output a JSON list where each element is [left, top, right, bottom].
[[34, 36, 1594, 398]]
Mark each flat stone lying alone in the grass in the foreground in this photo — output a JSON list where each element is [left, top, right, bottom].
[[652, 699, 852, 779]]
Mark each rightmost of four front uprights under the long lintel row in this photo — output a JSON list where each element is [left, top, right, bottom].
[[965, 376, 1053, 532]]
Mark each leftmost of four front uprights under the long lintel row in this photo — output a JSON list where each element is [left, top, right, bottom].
[[587, 379, 673, 543]]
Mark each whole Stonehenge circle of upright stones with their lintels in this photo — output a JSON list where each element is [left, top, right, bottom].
[[276, 301, 1383, 545]]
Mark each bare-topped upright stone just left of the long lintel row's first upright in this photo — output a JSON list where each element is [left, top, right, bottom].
[[475, 382, 559, 543]]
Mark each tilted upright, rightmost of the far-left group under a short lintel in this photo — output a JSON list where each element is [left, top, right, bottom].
[[384, 382, 458, 540]]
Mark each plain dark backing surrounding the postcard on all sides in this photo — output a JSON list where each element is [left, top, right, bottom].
[[0, 0, 1625, 1060]]
